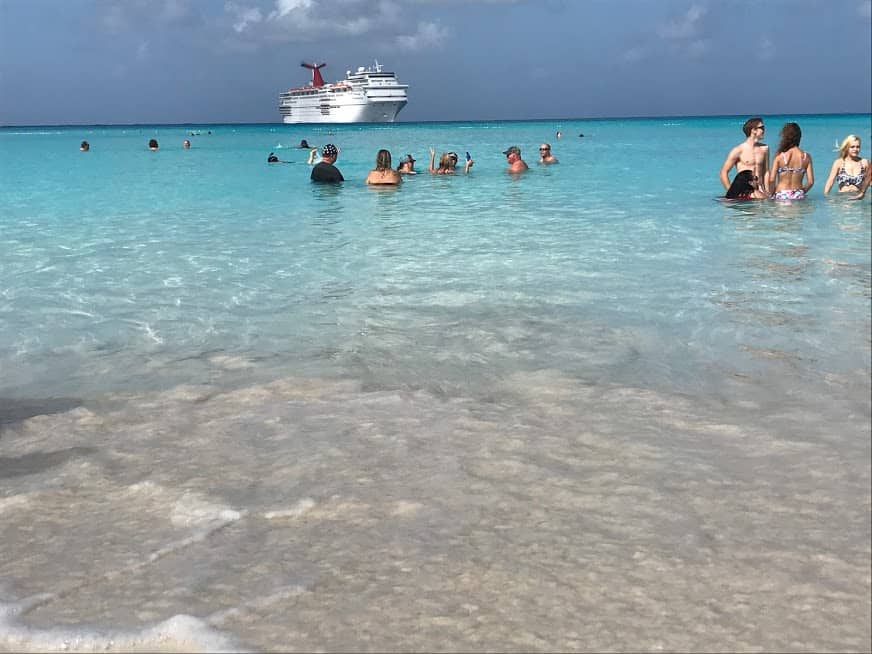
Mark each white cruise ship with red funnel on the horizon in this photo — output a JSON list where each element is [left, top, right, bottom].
[[279, 61, 409, 123]]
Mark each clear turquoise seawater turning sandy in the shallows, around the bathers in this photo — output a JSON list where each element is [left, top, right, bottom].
[[0, 116, 872, 651]]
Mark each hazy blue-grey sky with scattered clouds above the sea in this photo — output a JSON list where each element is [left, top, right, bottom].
[[0, 0, 872, 125]]
